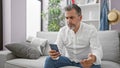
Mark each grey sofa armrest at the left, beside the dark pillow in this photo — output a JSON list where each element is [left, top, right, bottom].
[[0, 50, 16, 68]]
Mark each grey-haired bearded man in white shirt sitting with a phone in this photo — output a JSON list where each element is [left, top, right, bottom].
[[44, 4, 103, 68]]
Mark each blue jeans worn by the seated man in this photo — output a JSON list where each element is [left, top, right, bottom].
[[44, 56, 101, 68]]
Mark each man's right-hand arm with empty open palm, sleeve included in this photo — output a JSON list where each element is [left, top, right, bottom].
[[80, 28, 103, 68]]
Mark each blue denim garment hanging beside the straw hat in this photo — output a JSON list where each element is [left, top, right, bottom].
[[100, 0, 109, 31]]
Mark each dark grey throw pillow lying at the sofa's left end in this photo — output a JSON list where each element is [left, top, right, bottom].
[[5, 42, 40, 59]]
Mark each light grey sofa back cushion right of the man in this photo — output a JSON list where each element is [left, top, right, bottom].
[[98, 31, 120, 62]]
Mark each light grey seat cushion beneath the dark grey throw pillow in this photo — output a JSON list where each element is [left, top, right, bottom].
[[5, 56, 46, 68]]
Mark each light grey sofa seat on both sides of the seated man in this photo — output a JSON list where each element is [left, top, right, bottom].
[[5, 56, 120, 68]]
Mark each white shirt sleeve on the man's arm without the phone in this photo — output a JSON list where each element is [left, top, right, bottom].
[[90, 28, 103, 65]]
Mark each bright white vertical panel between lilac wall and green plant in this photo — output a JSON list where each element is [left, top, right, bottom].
[[26, 0, 41, 37]]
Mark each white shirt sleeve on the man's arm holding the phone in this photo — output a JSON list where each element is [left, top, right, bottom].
[[55, 29, 65, 56]]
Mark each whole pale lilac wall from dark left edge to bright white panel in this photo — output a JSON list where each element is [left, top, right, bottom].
[[3, 0, 26, 48]]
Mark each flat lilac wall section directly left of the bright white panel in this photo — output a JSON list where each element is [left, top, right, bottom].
[[11, 0, 26, 42]]
